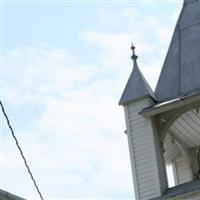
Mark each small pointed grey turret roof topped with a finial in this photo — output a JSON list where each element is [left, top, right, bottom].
[[119, 46, 154, 105]]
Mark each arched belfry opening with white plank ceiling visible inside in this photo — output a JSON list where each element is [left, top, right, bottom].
[[163, 108, 200, 188]]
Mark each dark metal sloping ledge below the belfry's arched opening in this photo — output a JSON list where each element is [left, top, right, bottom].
[[150, 181, 200, 200]]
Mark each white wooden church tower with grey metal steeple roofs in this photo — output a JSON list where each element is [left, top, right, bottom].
[[119, 0, 200, 200]]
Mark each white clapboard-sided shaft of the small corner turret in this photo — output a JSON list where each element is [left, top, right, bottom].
[[125, 99, 167, 200]]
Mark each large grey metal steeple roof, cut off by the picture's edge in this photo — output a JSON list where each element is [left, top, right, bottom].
[[155, 0, 200, 101]]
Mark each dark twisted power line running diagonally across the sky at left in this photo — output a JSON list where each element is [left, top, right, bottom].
[[0, 100, 44, 200]]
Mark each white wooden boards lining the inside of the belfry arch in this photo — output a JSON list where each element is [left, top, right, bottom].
[[164, 109, 200, 185]]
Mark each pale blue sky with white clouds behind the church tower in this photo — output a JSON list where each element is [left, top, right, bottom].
[[0, 0, 183, 200]]
